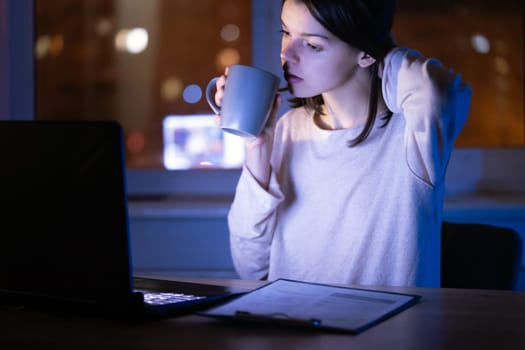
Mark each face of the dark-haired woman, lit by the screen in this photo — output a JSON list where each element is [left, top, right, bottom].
[[281, 0, 362, 98]]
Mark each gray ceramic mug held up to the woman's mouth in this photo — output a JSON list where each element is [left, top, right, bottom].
[[206, 64, 279, 137]]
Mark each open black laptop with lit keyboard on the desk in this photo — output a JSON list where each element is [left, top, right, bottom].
[[0, 121, 240, 318]]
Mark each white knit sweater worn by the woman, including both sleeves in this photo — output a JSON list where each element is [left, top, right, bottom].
[[228, 48, 471, 287]]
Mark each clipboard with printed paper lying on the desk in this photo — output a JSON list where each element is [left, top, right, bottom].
[[199, 279, 421, 334]]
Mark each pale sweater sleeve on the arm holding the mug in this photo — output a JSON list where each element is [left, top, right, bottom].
[[228, 163, 283, 280]]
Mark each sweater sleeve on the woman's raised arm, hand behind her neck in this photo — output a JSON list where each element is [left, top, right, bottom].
[[382, 48, 472, 186]]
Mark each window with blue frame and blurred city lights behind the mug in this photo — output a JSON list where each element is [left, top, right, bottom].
[[35, 0, 280, 195]]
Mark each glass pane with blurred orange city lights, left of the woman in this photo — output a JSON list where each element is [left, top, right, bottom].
[[35, 0, 252, 168]]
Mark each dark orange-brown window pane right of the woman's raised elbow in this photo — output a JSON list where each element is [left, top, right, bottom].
[[394, 0, 525, 147]]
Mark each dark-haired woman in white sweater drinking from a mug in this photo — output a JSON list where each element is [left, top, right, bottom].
[[215, 0, 471, 287]]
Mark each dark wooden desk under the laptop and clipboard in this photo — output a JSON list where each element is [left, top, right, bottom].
[[0, 278, 525, 350]]
